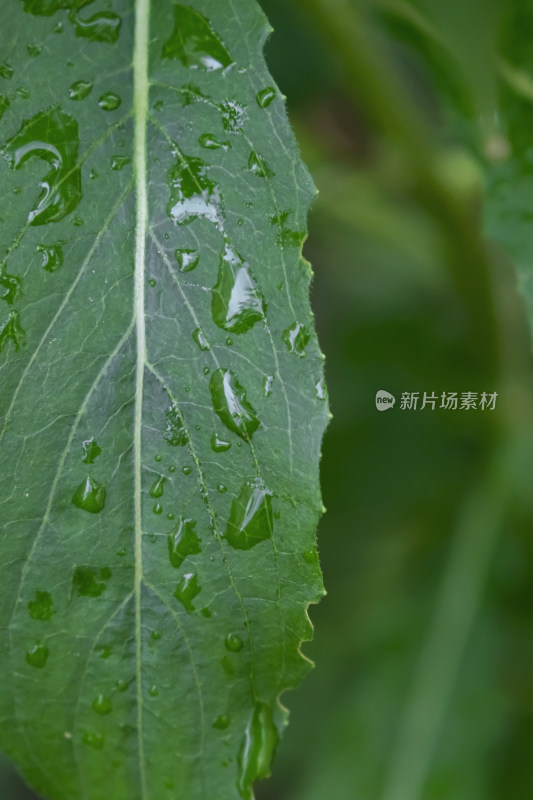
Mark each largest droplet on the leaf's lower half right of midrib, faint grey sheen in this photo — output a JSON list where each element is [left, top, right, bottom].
[[224, 478, 274, 550]]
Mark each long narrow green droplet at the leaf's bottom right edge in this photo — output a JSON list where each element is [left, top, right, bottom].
[[237, 702, 279, 800]]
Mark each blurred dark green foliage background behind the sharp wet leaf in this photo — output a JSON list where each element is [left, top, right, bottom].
[[6, 0, 533, 800]]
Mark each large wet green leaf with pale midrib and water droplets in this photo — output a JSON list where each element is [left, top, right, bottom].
[[0, 0, 328, 800]]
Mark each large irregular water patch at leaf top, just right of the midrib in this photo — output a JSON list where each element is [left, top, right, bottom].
[[162, 5, 233, 72]]
